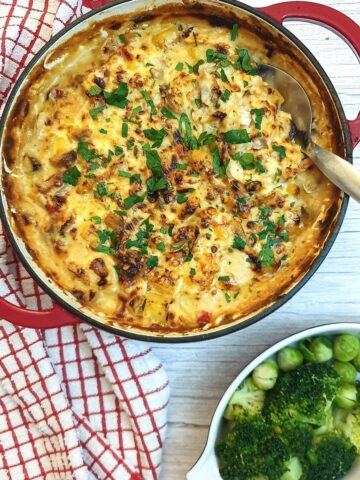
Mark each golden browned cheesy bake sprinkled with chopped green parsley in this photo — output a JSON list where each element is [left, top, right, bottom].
[[6, 16, 340, 332]]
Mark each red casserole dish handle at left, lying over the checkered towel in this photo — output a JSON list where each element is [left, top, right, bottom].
[[0, 298, 80, 328]]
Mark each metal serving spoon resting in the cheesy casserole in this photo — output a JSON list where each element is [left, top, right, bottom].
[[257, 64, 360, 203]]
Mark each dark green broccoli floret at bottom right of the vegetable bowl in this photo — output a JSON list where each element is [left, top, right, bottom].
[[304, 433, 357, 480]]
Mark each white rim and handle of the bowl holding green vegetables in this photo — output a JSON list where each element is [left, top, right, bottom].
[[186, 323, 360, 480]]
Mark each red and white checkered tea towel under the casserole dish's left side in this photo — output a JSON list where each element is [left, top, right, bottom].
[[0, 0, 169, 480]]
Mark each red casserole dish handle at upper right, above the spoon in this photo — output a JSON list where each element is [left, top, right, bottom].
[[258, 1, 360, 148]]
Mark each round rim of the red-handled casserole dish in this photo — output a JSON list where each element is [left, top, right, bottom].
[[0, 0, 352, 343]]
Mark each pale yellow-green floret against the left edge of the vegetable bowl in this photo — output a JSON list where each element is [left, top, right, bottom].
[[224, 378, 265, 420]]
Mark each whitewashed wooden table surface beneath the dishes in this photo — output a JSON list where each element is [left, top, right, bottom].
[[153, 0, 360, 480]]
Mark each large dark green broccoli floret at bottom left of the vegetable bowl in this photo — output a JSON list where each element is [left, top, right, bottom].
[[216, 415, 291, 480]]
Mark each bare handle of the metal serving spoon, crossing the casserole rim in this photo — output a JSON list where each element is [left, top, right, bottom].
[[306, 143, 360, 203]]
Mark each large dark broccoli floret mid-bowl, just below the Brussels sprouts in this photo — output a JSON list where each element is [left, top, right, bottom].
[[263, 362, 341, 426]]
